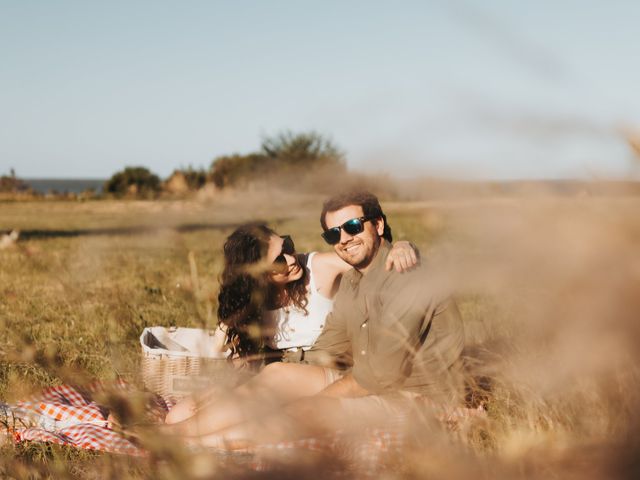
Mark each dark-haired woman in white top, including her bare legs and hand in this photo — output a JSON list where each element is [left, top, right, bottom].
[[166, 224, 417, 436]]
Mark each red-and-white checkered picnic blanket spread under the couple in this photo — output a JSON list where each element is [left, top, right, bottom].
[[0, 382, 484, 474]]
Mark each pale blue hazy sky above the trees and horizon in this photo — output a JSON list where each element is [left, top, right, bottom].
[[0, 0, 640, 179]]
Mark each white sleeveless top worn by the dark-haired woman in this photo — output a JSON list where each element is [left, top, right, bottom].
[[264, 252, 333, 350]]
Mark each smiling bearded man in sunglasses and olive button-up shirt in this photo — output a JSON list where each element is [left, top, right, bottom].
[[304, 192, 464, 421]]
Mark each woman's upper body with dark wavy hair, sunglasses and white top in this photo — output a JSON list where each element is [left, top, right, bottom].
[[218, 224, 332, 363]]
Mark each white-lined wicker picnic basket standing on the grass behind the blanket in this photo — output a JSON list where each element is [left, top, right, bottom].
[[140, 327, 230, 402]]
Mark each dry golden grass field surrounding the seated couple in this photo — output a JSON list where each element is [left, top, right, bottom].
[[0, 191, 640, 479]]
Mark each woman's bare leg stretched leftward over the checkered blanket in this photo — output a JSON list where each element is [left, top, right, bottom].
[[168, 363, 331, 436]]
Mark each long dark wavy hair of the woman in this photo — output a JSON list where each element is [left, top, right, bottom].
[[218, 223, 307, 360]]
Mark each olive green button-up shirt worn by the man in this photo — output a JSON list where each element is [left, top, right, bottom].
[[309, 240, 464, 400]]
